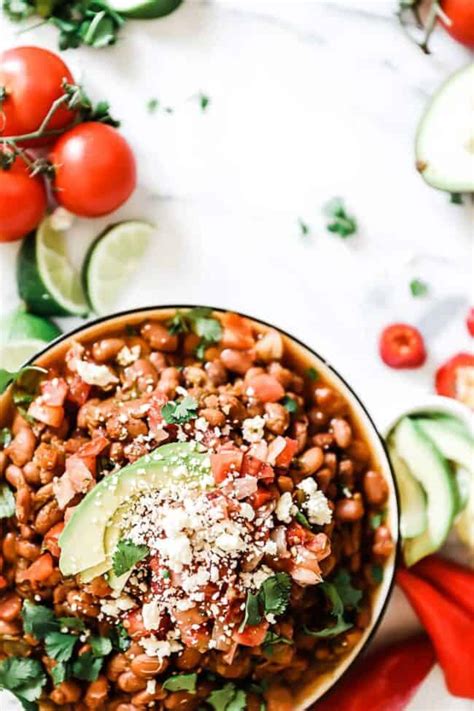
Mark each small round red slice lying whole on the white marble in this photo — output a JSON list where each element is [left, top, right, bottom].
[[379, 323, 426, 368]]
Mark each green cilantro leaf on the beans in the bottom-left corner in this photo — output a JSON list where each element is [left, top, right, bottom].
[[0, 657, 46, 709]]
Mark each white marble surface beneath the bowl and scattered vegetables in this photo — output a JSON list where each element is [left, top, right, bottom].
[[0, 0, 472, 711]]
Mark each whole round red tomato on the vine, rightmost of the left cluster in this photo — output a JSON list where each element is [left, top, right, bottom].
[[50, 122, 136, 217]]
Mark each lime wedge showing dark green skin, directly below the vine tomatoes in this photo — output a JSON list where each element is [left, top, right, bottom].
[[17, 219, 88, 316]]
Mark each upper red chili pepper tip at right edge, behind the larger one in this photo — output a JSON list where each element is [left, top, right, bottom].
[[410, 555, 474, 615]]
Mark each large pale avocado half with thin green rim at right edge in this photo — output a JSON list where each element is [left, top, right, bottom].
[[415, 64, 474, 193]]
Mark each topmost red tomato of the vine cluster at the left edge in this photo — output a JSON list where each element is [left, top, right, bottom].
[[0, 47, 74, 146]]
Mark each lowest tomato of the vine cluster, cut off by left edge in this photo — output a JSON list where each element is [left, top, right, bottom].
[[0, 158, 47, 242]]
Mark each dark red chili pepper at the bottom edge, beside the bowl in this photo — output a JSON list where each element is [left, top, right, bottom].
[[314, 636, 435, 711]]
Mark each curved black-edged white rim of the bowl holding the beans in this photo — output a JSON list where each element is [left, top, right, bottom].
[[6, 304, 401, 711]]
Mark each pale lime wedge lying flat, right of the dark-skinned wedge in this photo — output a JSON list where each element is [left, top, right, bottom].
[[82, 220, 154, 315]]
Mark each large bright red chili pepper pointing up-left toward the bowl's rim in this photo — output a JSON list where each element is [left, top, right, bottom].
[[397, 569, 474, 699]]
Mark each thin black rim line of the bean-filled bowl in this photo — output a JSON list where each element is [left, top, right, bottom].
[[21, 304, 401, 705]]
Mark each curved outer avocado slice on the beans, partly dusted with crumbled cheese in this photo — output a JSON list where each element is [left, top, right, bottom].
[[59, 442, 211, 580]]
